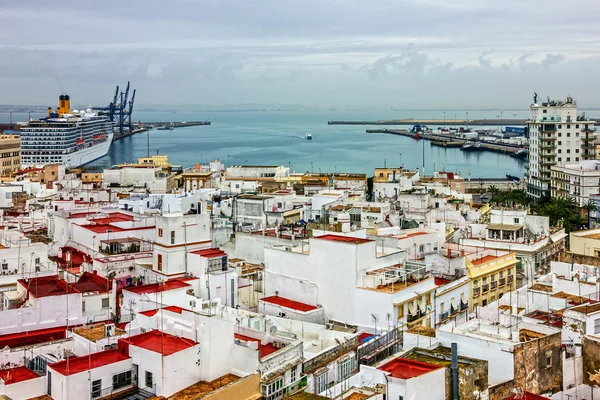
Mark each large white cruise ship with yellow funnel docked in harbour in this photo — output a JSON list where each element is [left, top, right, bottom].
[[21, 95, 114, 168]]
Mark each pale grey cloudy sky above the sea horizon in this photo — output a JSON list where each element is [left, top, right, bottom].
[[0, 0, 600, 109]]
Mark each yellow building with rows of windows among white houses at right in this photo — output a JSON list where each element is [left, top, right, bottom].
[[465, 250, 519, 312]]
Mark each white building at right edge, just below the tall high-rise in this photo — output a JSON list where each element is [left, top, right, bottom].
[[550, 160, 600, 206]]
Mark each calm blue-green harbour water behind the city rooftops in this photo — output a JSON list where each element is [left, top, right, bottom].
[[0, 111, 529, 178]]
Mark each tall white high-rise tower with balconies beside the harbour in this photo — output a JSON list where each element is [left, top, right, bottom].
[[525, 94, 596, 199]]
